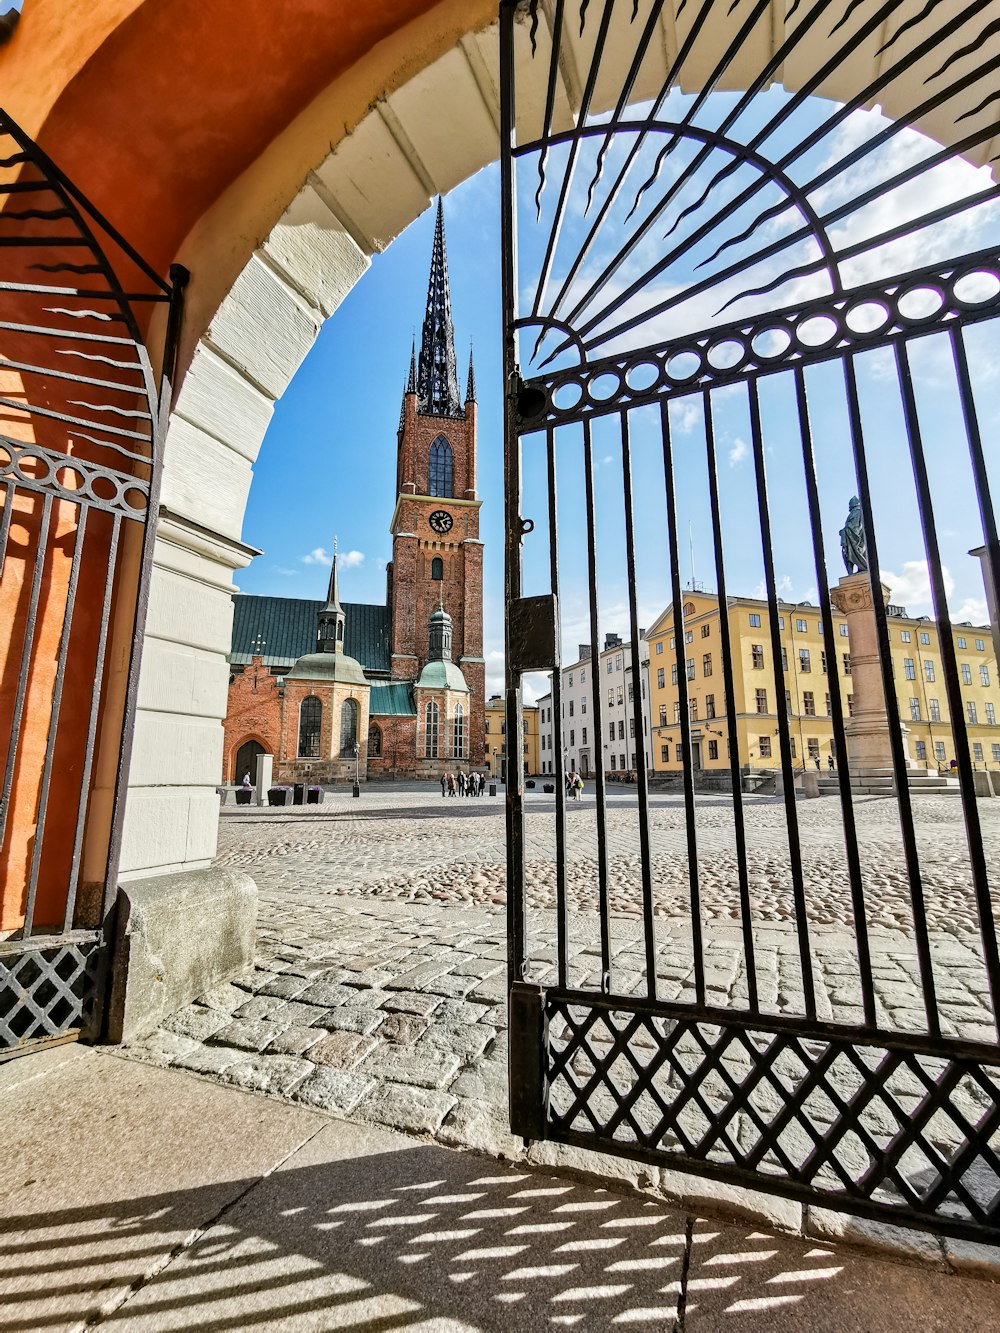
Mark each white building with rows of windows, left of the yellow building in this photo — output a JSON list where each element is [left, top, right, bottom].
[[539, 635, 652, 777]]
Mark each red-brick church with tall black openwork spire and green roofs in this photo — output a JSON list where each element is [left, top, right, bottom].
[[223, 200, 485, 782]]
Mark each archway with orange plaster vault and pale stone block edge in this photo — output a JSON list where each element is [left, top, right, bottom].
[[0, 0, 997, 895]]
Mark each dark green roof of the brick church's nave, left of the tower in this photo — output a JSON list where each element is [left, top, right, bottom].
[[229, 592, 392, 676]]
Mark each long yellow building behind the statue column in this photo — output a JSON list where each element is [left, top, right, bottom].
[[647, 592, 1000, 772]]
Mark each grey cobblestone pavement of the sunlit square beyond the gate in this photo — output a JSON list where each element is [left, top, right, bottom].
[[129, 788, 1000, 1237]]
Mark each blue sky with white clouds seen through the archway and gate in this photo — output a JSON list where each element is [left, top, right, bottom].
[[239, 89, 1000, 692]]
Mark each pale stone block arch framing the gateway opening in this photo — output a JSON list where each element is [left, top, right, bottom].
[[121, 0, 1000, 880]]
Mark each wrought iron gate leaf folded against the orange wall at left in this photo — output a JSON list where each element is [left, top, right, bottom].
[[0, 112, 187, 1060]]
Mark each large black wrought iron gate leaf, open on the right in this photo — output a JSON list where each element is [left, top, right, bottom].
[[500, 0, 1000, 1241]]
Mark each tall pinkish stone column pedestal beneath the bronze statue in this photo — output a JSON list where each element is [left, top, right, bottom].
[[831, 572, 892, 777]]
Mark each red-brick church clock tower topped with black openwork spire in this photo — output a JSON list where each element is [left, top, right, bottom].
[[388, 199, 485, 764]]
